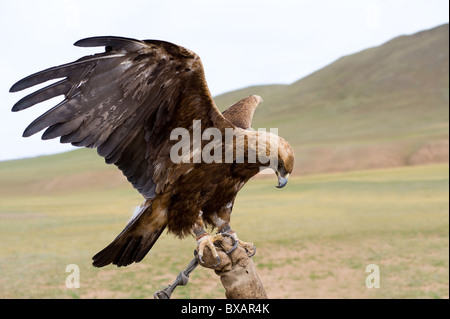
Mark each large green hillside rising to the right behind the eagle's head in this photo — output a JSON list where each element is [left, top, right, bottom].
[[215, 24, 449, 173]]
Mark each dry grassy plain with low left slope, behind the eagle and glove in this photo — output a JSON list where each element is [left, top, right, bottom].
[[0, 150, 449, 298]]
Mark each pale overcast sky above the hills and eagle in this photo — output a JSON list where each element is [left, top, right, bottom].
[[0, 0, 449, 160]]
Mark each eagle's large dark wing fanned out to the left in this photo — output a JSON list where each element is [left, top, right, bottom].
[[10, 36, 232, 198]]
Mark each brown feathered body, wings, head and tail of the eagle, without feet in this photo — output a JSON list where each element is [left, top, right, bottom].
[[10, 36, 293, 267]]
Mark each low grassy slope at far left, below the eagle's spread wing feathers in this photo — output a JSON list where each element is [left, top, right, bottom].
[[0, 149, 124, 198]]
